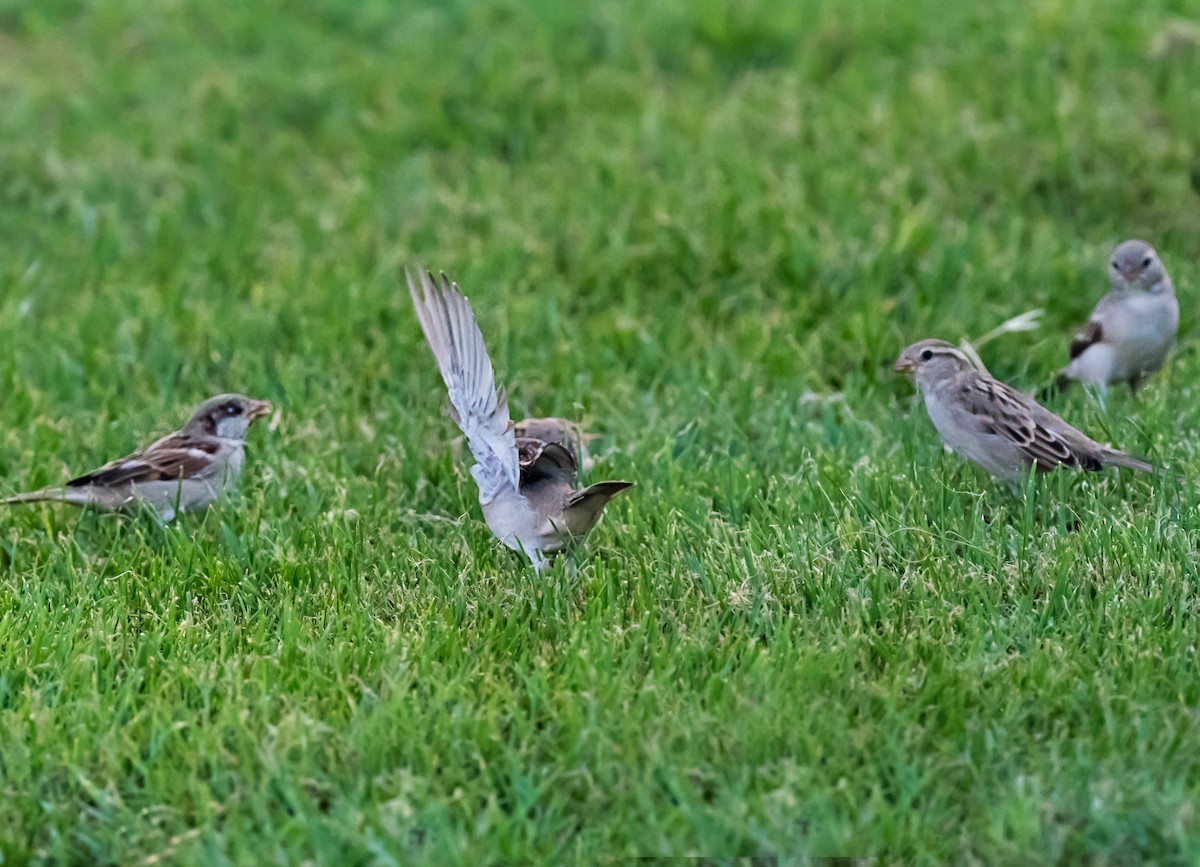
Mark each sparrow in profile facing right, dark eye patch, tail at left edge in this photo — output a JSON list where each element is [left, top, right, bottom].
[[0, 394, 271, 521]]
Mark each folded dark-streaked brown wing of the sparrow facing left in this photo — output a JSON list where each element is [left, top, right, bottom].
[[961, 376, 1104, 472]]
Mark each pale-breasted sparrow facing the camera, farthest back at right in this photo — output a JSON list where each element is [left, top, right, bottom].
[[1063, 240, 1180, 393]]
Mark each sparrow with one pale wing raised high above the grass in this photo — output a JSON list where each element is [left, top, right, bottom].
[[404, 270, 632, 572]]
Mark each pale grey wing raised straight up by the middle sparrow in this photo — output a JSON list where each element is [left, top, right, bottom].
[[404, 270, 521, 503]]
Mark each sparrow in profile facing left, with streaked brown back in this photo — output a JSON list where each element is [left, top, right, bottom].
[[893, 340, 1153, 490]]
